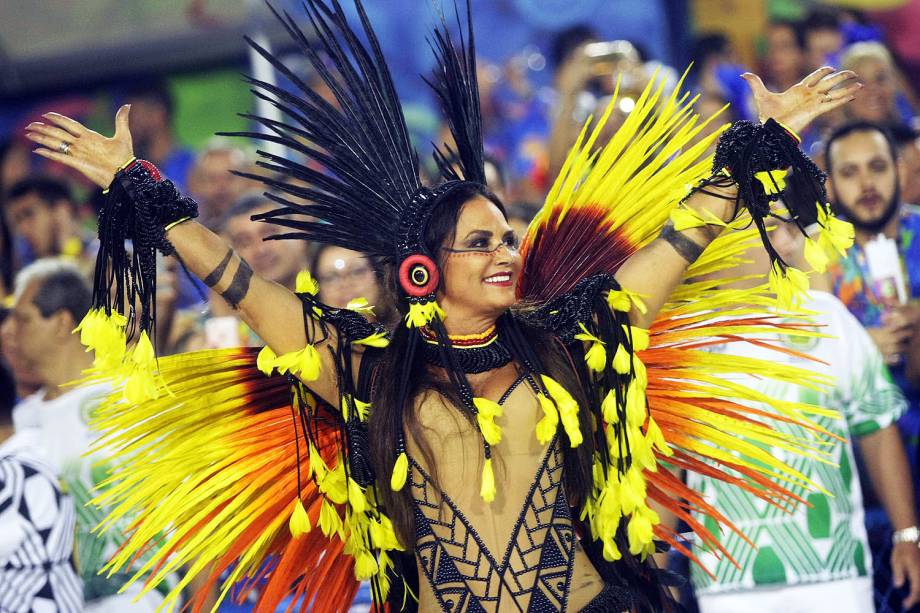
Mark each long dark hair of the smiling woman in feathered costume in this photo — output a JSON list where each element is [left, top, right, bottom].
[[368, 184, 594, 551]]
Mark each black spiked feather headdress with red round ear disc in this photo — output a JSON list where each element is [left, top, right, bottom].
[[222, 0, 485, 325]]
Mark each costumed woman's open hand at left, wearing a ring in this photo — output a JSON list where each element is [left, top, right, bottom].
[[26, 105, 134, 188]]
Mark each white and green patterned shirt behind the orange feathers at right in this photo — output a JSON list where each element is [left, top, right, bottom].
[[687, 292, 905, 594]]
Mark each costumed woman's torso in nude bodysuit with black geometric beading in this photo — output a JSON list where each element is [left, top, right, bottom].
[[407, 365, 603, 612]]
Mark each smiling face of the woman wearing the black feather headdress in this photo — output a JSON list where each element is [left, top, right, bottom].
[[438, 196, 521, 332]]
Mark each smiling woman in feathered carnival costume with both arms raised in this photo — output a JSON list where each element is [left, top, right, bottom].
[[28, 0, 858, 612]]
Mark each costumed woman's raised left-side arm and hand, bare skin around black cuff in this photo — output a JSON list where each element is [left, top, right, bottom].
[[26, 106, 339, 406]]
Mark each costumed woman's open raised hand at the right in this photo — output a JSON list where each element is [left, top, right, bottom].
[[741, 66, 862, 132]]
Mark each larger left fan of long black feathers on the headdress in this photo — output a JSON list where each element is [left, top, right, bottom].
[[217, 0, 422, 263]]
